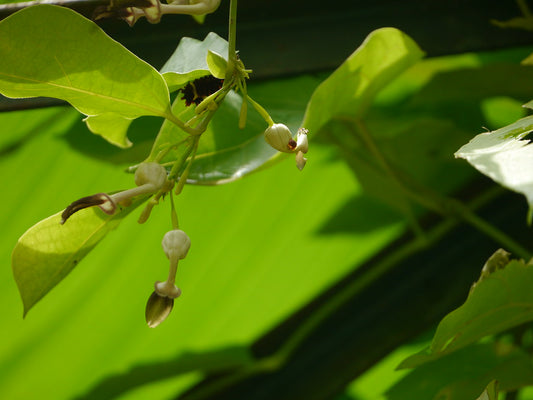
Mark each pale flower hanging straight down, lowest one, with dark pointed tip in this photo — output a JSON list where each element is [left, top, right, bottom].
[[145, 229, 191, 328]]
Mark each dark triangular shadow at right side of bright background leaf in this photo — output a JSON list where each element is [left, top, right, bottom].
[[318, 194, 403, 235]]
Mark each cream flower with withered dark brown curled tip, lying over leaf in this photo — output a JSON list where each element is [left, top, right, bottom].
[[61, 163, 167, 224]]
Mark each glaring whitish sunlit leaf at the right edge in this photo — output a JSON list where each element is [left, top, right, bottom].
[[455, 116, 533, 219]]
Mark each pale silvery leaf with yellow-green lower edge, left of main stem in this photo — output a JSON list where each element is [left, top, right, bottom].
[[161, 32, 228, 92]]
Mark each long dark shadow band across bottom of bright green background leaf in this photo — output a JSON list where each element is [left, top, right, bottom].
[[75, 346, 252, 400]]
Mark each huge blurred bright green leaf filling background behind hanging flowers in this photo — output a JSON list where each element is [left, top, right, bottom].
[[0, 101, 399, 400]]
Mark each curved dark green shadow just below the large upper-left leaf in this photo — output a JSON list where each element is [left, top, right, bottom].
[[62, 117, 163, 165]]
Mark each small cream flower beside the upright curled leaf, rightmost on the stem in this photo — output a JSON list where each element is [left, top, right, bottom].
[[264, 124, 309, 171]]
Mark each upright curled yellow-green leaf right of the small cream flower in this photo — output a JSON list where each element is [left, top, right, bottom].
[[303, 28, 424, 133]]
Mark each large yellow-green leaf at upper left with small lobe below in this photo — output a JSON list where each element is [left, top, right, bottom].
[[0, 5, 170, 146]]
